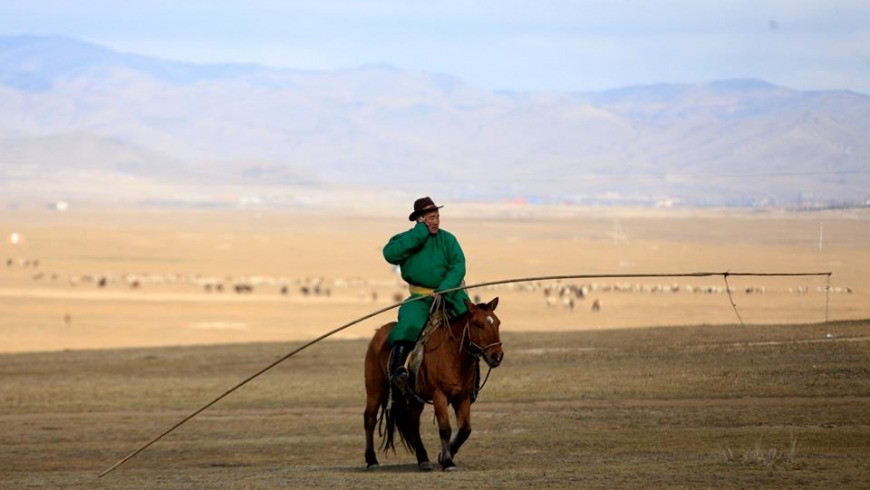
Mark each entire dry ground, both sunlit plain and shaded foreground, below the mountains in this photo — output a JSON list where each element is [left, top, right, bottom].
[[0, 205, 870, 488]]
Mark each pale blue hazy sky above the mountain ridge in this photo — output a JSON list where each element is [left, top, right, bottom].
[[0, 0, 870, 94]]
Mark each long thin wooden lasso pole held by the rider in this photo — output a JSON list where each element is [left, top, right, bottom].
[[99, 272, 832, 478]]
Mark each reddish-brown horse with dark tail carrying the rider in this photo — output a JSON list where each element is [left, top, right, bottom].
[[364, 298, 504, 471]]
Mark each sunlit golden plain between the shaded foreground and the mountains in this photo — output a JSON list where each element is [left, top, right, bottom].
[[0, 203, 870, 352]]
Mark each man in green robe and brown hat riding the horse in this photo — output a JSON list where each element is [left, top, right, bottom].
[[383, 197, 479, 394]]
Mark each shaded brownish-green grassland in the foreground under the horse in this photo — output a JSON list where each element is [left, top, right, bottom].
[[0, 321, 870, 489]]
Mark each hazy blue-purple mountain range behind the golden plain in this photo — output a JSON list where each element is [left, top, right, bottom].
[[0, 36, 870, 209]]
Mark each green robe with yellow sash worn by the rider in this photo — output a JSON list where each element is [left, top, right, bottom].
[[384, 222, 468, 345]]
